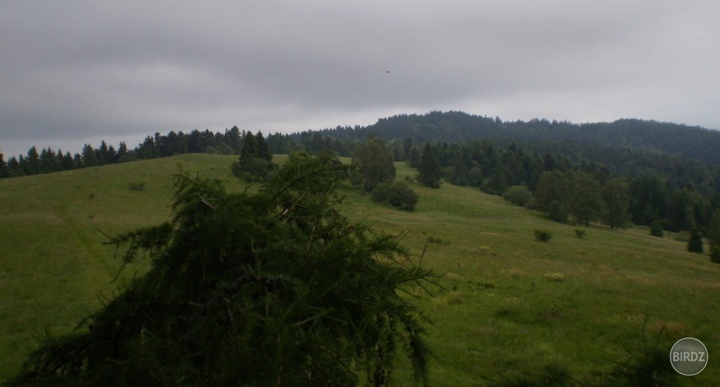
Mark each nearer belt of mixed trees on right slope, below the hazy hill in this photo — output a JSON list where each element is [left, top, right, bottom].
[[408, 141, 720, 235]]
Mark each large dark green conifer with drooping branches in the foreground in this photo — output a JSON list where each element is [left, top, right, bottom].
[[10, 153, 430, 386]]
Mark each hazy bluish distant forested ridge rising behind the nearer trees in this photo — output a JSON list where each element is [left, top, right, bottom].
[[296, 111, 720, 165]]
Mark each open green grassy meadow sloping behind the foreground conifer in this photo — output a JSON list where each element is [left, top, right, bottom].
[[0, 154, 720, 386]]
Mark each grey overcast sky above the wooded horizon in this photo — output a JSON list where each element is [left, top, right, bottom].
[[0, 0, 720, 160]]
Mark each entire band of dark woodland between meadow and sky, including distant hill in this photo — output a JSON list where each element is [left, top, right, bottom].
[[0, 112, 720, 241]]
